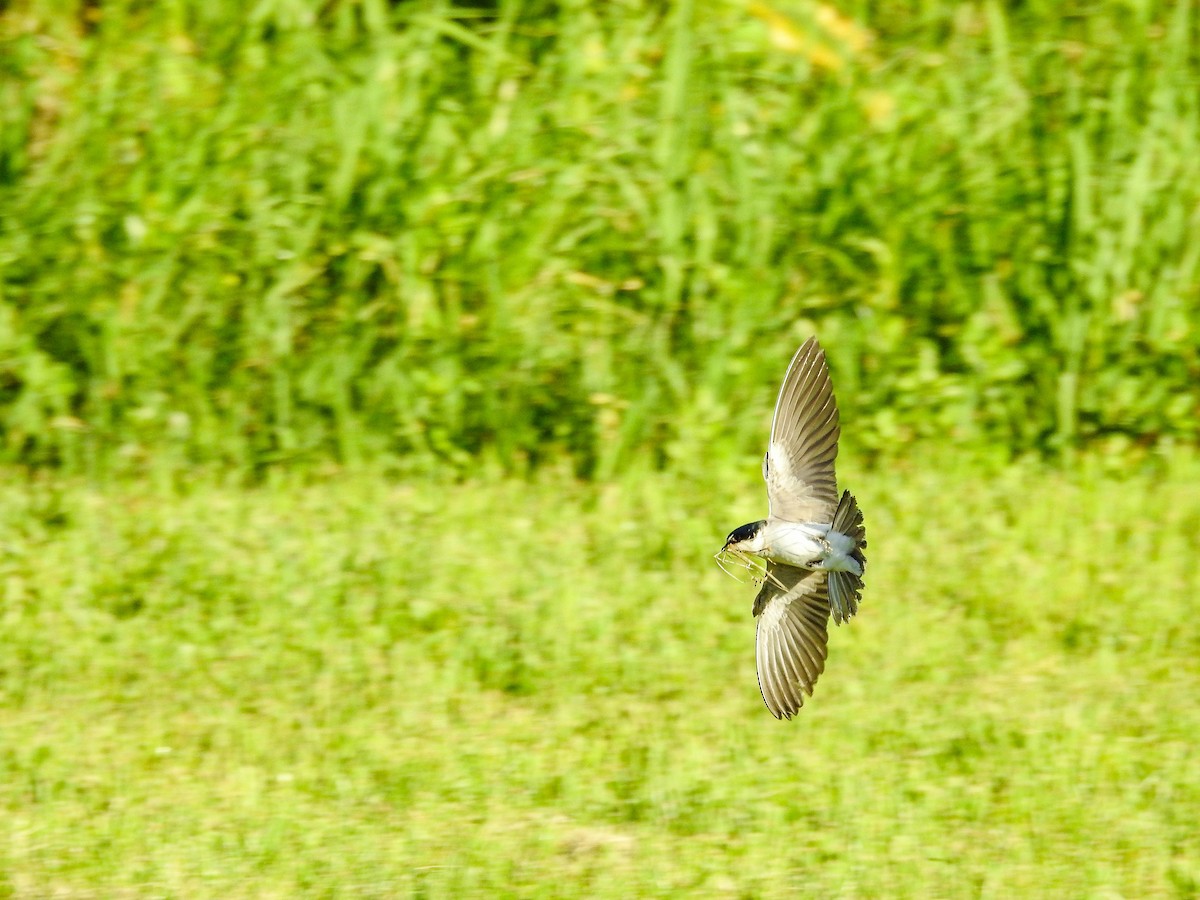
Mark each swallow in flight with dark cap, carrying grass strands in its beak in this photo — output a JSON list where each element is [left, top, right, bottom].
[[718, 337, 866, 719]]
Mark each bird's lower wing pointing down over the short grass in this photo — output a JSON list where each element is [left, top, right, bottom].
[[754, 562, 829, 719]]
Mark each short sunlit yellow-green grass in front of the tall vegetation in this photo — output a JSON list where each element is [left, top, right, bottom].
[[0, 451, 1200, 898]]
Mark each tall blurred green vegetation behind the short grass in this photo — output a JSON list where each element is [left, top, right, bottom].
[[0, 0, 1200, 476]]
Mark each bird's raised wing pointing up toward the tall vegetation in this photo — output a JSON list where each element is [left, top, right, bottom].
[[762, 337, 841, 522]]
